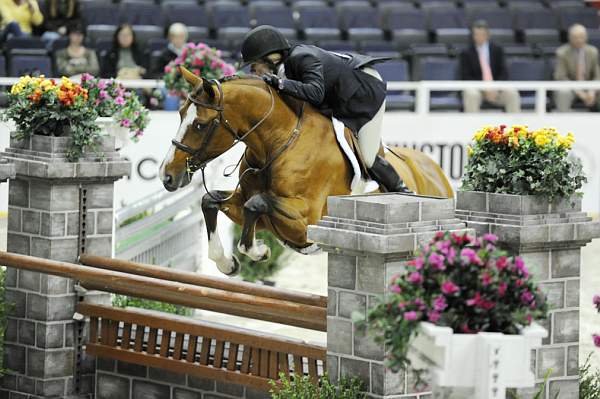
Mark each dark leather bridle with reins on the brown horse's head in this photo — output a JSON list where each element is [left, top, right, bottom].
[[171, 79, 275, 178]]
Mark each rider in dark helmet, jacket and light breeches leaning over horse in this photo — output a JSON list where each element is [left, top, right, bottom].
[[242, 25, 410, 192]]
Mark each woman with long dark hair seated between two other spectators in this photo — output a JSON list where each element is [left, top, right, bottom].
[[102, 24, 146, 79]]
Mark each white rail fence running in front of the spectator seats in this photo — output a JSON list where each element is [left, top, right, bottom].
[[0, 78, 600, 115]]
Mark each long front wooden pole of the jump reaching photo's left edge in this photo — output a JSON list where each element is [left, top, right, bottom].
[[0, 251, 327, 331]]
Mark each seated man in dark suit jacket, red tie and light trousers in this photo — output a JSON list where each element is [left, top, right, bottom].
[[460, 20, 521, 112]]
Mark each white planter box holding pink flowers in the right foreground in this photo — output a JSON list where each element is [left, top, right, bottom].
[[408, 322, 548, 399]]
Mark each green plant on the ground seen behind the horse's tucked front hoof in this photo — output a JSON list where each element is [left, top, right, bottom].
[[233, 225, 285, 283]]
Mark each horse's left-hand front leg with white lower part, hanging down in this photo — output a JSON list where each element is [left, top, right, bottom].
[[202, 190, 242, 276]]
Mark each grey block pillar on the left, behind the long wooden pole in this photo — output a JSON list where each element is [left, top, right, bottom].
[[0, 136, 130, 399]]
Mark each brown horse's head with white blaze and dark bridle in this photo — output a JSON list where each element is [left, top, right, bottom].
[[159, 67, 234, 191]]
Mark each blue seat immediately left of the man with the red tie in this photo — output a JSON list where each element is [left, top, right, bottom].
[[417, 57, 461, 110]]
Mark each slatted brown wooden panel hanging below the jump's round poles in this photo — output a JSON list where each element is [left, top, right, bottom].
[[77, 303, 327, 391]]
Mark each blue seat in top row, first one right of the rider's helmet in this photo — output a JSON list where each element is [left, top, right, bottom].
[[294, 1, 342, 40]]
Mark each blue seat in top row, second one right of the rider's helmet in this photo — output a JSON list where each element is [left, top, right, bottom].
[[337, 1, 384, 40]]
